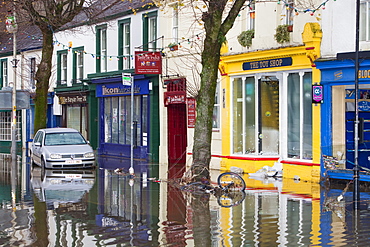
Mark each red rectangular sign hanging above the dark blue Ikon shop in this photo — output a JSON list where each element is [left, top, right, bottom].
[[135, 51, 162, 74]]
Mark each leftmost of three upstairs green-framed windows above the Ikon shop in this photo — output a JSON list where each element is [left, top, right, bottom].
[[96, 25, 108, 73]]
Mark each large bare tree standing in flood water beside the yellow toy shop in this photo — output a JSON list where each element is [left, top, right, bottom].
[[154, 0, 249, 180]]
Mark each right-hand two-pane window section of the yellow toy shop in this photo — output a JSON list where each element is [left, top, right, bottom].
[[287, 72, 312, 159]]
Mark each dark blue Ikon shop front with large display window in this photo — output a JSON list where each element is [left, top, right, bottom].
[[91, 75, 156, 167]]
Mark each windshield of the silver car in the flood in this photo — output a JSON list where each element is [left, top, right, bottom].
[[45, 132, 86, 146]]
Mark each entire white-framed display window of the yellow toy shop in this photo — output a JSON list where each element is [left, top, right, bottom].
[[231, 72, 312, 159]]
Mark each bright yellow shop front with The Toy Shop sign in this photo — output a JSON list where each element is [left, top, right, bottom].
[[220, 23, 322, 181]]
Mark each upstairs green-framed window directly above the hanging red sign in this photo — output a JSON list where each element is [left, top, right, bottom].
[[143, 11, 157, 51]]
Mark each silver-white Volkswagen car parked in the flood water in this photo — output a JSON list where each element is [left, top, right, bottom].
[[30, 128, 95, 169]]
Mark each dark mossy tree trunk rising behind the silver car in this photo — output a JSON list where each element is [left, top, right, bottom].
[[34, 27, 54, 133]]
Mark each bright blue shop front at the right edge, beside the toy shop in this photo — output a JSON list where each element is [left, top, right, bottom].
[[315, 52, 370, 181]]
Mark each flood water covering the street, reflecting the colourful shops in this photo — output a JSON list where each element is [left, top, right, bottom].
[[0, 155, 370, 247]]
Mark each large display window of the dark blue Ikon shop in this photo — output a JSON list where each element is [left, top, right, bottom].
[[104, 96, 148, 146]]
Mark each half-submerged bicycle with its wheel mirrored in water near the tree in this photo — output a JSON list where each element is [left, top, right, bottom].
[[180, 172, 246, 207]]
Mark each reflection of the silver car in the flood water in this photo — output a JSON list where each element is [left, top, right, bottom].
[[31, 166, 95, 208]]
